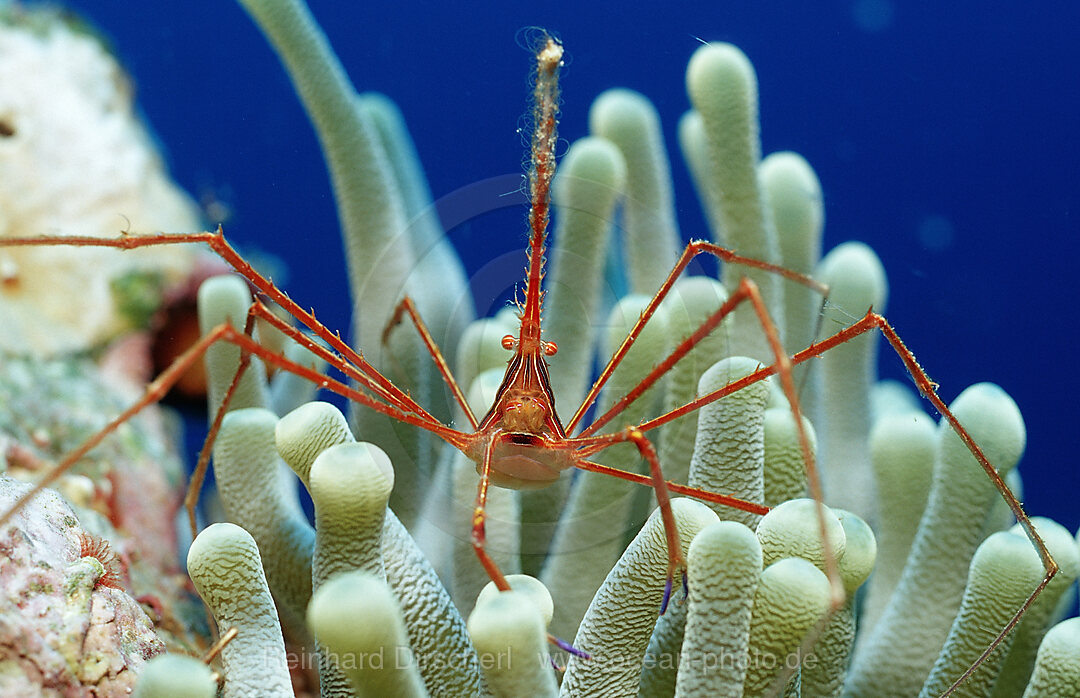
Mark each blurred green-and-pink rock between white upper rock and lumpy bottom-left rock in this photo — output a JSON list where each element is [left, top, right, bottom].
[[0, 357, 184, 583]]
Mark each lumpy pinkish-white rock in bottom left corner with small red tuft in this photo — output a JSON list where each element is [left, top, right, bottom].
[[0, 476, 165, 696]]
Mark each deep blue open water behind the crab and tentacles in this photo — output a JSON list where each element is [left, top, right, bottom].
[[71, 0, 1080, 531]]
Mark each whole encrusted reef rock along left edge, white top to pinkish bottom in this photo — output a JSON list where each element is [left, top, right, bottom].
[[0, 8, 205, 696]]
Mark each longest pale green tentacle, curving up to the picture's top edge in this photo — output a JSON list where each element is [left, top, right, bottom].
[[241, 0, 440, 531]]
